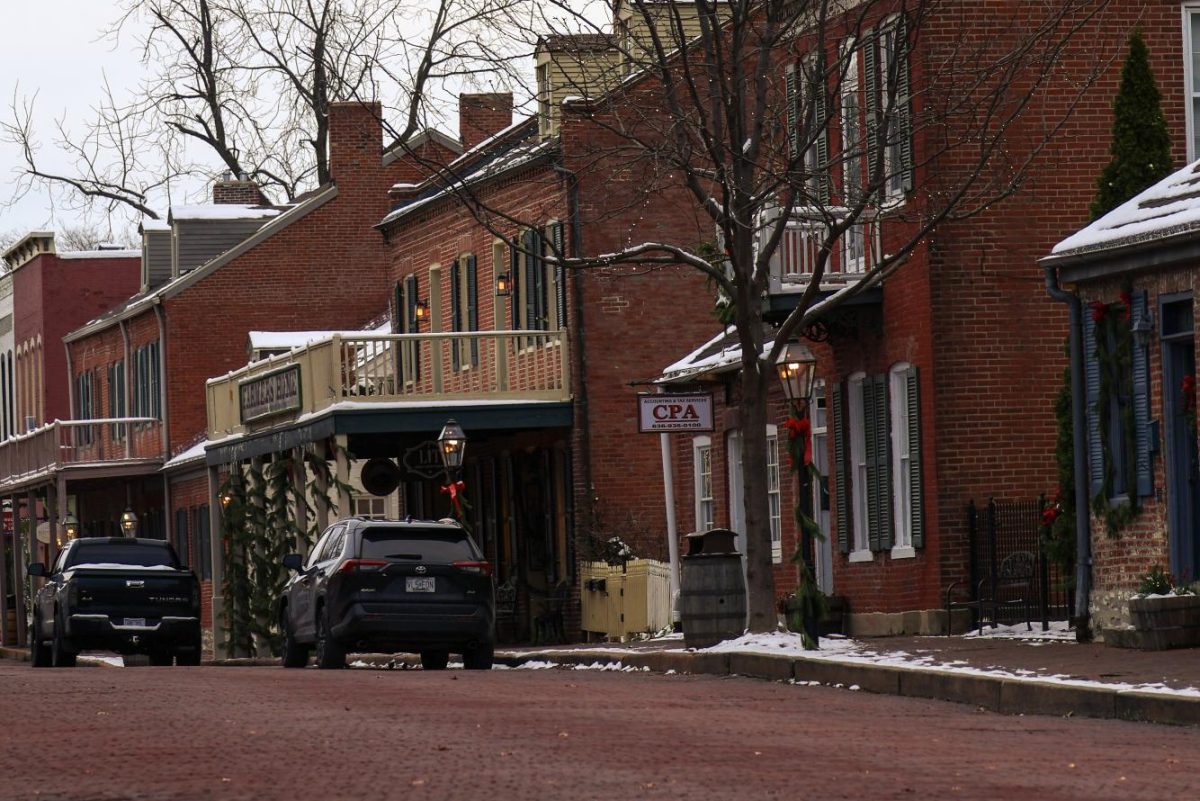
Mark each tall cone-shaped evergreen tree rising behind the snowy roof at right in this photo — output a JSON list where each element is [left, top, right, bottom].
[[1091, 30, 1171, 219]]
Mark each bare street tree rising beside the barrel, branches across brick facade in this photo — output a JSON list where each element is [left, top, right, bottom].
[[422, 0, 1115, 631]]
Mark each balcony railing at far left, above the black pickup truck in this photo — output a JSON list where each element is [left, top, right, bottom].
[[0, 417, 162, 484]]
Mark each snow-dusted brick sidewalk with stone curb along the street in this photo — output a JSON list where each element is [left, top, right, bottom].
[[9, 624, 1200, 725]]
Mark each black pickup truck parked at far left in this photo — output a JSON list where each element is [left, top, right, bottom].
[[29, 537, 200, 668]]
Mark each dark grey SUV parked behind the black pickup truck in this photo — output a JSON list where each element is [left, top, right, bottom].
[[278, 518, 496, 670]]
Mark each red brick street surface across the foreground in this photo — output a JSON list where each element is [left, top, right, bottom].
[[0, 663, 1200, 801]]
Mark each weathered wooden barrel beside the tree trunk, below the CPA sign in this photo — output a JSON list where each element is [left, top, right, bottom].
[[679, 553, 746, 648]]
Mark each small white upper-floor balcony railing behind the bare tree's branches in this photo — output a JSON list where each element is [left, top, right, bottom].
[[763, 210, 883, 293]]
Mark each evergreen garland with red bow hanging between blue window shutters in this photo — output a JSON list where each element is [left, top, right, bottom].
[[1088, 287, 1140, 537]]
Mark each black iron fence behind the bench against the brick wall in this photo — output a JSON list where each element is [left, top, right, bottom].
[[967, 498, 1074, 626]]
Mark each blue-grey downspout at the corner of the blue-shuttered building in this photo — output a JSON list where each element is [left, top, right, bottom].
[[1043, 264, 1092, 642]]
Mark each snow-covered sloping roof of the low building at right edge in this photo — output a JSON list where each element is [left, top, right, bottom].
[[1051, 155, 1200, 255]]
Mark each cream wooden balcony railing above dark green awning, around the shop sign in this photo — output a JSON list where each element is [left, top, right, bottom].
[[208, 331, 570, 439]]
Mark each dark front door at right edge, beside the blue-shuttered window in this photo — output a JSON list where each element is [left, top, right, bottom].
[[1162, 299, 1200, 582]]
